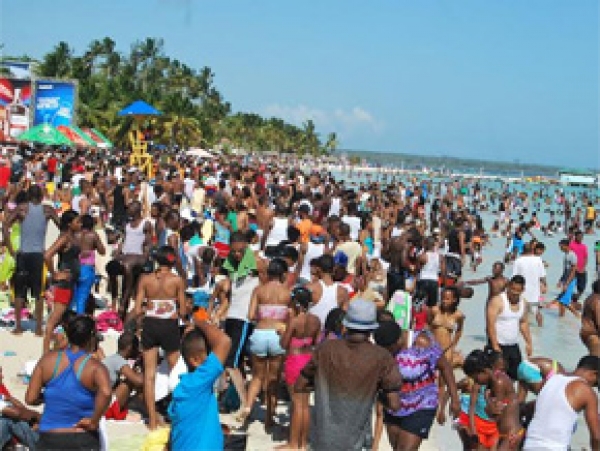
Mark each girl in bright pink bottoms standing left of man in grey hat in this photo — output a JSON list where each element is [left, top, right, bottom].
[[277, 287, 321, 449]]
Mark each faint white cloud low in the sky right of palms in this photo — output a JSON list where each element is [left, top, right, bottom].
[[263, 104, 383, 134]]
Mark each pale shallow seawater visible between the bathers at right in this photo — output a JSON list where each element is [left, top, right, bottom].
[[324, 171, 600, 451]]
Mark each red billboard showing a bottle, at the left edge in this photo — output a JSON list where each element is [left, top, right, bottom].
[[0, 77, 31, 140]]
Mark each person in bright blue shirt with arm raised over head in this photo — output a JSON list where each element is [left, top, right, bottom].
[[169, 319, 231, 451]]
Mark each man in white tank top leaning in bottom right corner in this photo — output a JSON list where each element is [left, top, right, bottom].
[[523, 355, 600, 451]]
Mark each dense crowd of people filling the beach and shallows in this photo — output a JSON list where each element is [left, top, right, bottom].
[[0, 149, 600, 450]]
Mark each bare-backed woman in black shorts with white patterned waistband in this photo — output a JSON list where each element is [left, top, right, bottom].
[[134, 246, 186, 430]]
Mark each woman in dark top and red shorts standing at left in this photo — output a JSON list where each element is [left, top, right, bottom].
[[43, 210, 81, 353]]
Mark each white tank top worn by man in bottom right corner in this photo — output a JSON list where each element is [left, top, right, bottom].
[[523, 374, 580, 451]]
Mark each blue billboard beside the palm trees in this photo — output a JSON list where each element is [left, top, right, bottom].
[[33, 80, 75, 127]]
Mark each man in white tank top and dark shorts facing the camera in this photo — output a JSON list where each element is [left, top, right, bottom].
[[486, 275, 533, 380]]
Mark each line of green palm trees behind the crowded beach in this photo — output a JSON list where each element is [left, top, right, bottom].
[[4, 37, 338, 155]]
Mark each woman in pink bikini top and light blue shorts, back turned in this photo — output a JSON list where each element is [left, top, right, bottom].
[[240, 258, 291, 429]]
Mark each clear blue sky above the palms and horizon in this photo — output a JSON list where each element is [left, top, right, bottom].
[[0, 0, 600, 168]]
